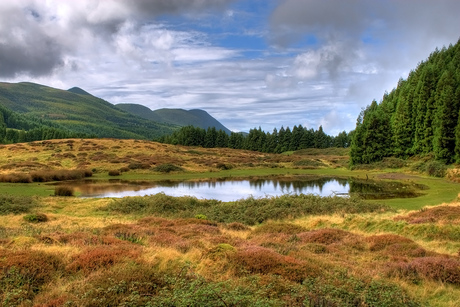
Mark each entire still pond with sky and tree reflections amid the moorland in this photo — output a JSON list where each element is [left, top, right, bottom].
[[66, 177, 423, 201]]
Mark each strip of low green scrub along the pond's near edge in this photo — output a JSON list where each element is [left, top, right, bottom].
[[105, 193, 391, 225]]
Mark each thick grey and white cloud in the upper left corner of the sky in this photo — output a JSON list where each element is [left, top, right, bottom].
[[0, 0, 235, 78]]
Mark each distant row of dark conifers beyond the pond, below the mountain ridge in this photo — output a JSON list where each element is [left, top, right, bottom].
[[158, 125, 350, 153]]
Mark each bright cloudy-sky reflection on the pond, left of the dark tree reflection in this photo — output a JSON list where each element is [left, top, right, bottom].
[[79, 179, 349, 201]]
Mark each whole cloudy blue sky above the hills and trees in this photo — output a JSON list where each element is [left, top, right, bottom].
[[0, 0, 460, 135]]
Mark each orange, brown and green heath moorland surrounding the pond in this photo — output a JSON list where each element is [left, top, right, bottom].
[[0, 139, 460, 306]]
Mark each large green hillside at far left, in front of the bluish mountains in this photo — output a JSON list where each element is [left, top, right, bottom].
[[0, 82, 175, 139]]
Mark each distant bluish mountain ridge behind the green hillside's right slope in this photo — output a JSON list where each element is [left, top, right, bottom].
[[116, 103, 231, 134]]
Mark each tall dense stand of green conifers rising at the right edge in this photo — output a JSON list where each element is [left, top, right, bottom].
[[350, 40, 460, 165]]
